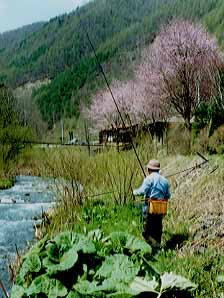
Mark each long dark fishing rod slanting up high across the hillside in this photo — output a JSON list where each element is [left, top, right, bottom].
[[79, 15, 146, 177]]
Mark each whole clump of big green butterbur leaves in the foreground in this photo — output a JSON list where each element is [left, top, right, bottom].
[[11, 229, 197, 298]]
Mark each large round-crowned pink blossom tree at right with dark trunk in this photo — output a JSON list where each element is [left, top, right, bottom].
[[139, 21, 222, 130]]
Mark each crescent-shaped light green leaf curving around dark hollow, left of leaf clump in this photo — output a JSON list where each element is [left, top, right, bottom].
[[43, 247, 78, 275]]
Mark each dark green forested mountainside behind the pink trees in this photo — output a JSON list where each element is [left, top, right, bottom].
[[0, 0, 224, 127]]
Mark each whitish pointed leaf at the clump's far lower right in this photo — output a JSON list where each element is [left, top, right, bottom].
[[161, 272, 197, 292]]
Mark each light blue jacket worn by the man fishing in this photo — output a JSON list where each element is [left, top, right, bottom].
[[133, 172, 171, 199]]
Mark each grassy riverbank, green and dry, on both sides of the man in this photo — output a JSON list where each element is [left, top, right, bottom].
[[21, 142, 224, 298]]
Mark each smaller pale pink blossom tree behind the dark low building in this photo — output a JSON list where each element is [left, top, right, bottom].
[[85, 78, 168, 129]]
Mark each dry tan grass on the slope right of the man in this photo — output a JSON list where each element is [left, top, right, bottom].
[[162, 156, 224, 250]]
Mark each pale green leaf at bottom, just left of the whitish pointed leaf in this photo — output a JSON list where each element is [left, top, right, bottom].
[[130, 277, 159, 295]]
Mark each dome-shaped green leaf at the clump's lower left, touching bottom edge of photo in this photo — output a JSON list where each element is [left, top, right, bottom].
[[27, 274, 68, 298]]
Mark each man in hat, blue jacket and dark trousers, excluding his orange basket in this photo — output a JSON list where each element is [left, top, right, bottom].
[[133, 159, 171, 247]]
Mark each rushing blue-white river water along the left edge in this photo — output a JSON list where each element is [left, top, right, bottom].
[[0, 176, 56, 298]]
